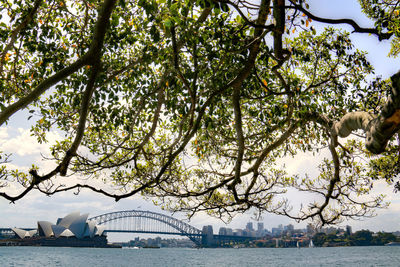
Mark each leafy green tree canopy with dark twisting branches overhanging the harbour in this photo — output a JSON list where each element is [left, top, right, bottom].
[[0, 0, 400, 225]]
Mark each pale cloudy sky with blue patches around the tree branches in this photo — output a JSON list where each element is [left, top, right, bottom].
[[0, 0, 400, 241]]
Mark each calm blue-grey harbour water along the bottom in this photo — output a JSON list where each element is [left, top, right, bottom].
[[0, 247, 400, 267]]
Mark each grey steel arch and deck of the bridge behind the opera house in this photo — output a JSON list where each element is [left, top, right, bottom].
[[88, 210, 203, 246]]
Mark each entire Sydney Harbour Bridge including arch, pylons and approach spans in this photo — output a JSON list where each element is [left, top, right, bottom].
[[0, 210, 254, 247]]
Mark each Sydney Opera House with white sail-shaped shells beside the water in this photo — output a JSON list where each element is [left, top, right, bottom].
[[7, 212, 117, 247]]
